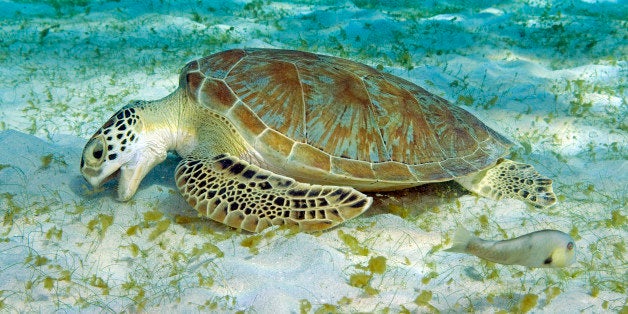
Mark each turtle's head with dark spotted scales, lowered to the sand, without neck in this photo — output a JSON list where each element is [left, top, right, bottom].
[[81, 101, 167, 201]]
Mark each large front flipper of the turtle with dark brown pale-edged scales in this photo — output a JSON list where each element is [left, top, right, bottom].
[[175, 155, 372, 232]]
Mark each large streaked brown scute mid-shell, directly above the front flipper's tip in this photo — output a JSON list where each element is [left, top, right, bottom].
[[300, 65, 390, 162]]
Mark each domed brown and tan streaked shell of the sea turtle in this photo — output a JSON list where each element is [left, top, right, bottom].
[[180, 49, 511, 191]]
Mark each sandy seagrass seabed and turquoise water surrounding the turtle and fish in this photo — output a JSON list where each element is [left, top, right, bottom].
[[0, 0, 628, 313]]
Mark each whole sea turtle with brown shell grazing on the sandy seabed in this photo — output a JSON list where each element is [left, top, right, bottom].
[[81, 49, 556, 232]]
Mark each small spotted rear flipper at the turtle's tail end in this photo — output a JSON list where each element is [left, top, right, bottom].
[[456, 159, 556, 207]]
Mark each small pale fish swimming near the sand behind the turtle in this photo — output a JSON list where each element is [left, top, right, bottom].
[[445, 227, 576, 267]]
